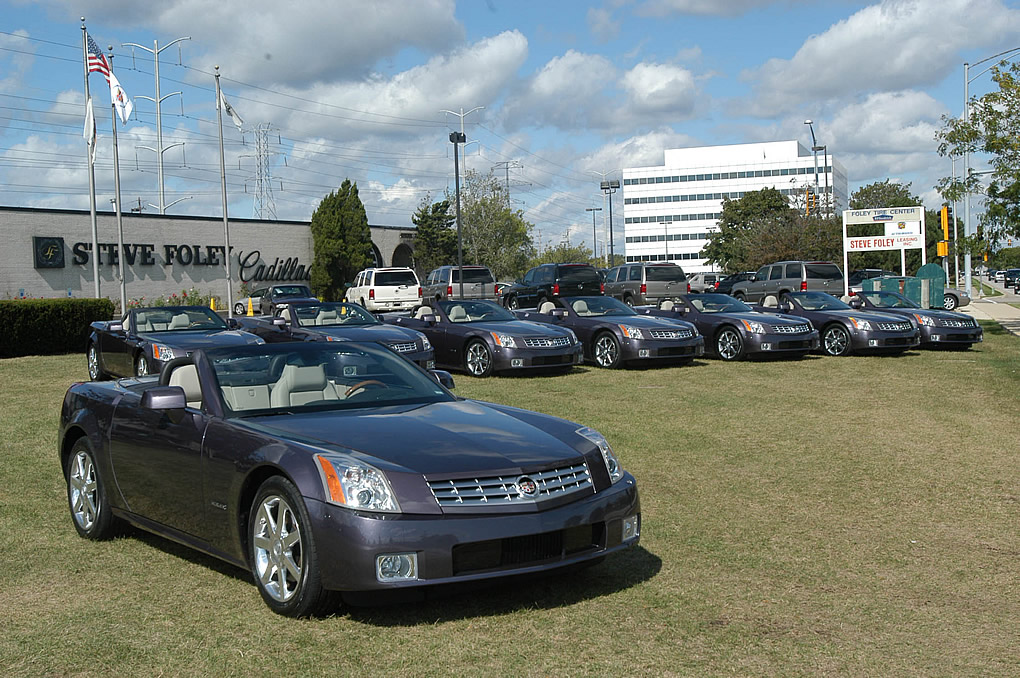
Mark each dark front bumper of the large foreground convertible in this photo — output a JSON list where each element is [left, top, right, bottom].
[[305, 473, 641, 591]]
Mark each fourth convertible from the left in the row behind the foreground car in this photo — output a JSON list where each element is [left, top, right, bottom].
[[516, 297, 705, 368]]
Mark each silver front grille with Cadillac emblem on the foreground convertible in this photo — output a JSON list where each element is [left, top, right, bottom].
[[428, 462, 595, 507]]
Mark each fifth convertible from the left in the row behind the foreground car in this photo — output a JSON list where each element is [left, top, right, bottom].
[[644, 294, 818, 360]]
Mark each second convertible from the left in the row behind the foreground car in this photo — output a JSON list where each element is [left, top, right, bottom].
[[234, 302, 436, 369]]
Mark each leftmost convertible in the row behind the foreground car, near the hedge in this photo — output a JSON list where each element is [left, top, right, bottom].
[[85, 306, 263, 380]]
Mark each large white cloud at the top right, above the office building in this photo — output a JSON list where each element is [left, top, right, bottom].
[[742, 0, 1020, 117]]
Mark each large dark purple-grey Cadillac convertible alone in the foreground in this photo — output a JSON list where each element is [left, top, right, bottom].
[[57, 342, 641, 616]]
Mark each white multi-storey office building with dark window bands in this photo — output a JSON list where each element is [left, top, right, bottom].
[[622, 141, 849, 273]]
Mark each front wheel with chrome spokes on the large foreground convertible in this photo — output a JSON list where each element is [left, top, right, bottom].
[[248, 476, 338, 617]]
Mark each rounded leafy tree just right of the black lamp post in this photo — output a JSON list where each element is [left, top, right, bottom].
[[447, 170, 534, 278]]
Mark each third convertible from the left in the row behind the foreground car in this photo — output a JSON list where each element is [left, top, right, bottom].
[[387, 299, 581, 376]]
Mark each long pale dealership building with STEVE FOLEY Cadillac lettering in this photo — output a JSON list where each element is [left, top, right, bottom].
[[0, 207, 415, 302]]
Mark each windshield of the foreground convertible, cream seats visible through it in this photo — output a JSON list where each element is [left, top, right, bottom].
[[206, 342, 453, 416]]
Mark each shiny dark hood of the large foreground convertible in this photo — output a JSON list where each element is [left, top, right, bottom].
[[243, 401, 583, 475]]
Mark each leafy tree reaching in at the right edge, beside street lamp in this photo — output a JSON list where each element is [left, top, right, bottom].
[[935, 62, 1020, 242]]
